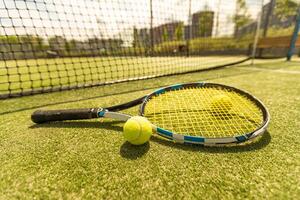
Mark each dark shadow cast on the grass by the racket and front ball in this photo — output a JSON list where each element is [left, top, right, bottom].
[[29, 121, 271, 155]]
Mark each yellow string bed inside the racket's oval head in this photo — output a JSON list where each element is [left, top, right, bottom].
[[144, 87, 263, 137]]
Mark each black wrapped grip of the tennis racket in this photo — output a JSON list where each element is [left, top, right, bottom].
[[31, 108, 99, 124]]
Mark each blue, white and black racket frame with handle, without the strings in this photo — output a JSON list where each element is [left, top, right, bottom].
[[31, 82, 270, 146]]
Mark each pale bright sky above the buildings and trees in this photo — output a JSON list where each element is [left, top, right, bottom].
[[0, 0, 267, 42]]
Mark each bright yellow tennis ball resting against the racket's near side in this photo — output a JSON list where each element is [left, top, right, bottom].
[[123, 116, 152, 145]]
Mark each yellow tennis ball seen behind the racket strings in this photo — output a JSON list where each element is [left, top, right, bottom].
[[210, 94, 232, 112]]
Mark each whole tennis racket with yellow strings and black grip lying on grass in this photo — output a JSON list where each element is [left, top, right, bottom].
[[31, 82, 270, 145]]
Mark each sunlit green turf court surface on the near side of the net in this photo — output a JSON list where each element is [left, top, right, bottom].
[[0, 59, 300, 199]]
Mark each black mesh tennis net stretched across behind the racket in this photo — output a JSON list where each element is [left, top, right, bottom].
[[0, 0, 295, 98]]
